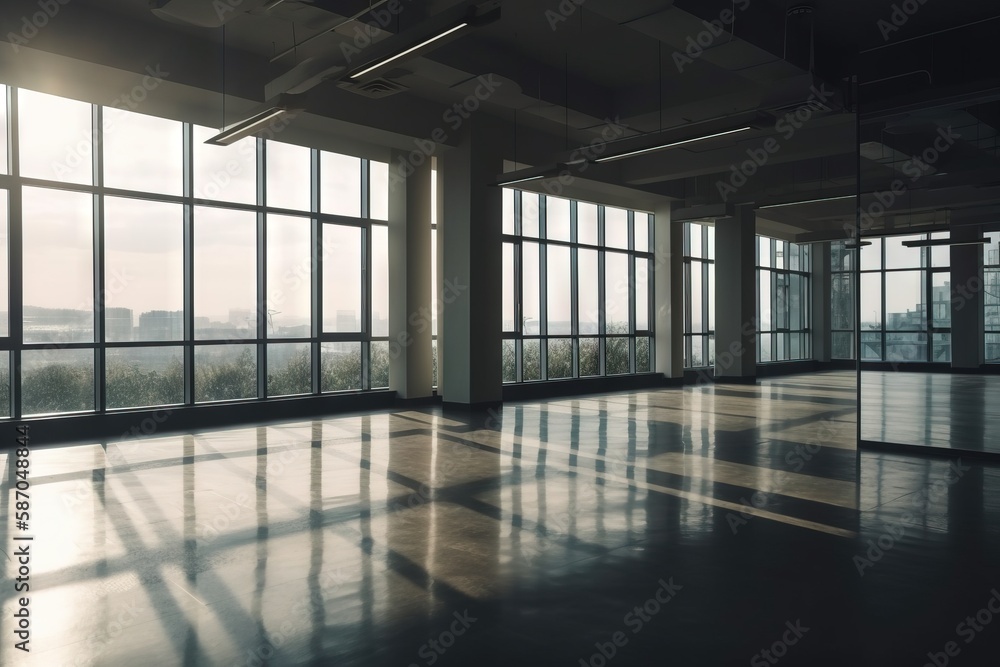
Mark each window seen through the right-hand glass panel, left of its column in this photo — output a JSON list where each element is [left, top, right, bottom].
[[860, 234, 951, 363]]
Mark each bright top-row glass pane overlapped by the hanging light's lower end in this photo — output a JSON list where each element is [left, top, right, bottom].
[[192, 125, 257, 204]]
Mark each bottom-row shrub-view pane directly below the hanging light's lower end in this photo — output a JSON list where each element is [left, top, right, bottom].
[[194, 345, 257, 403]]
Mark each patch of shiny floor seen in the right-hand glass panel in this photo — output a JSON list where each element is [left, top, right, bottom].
[[861, 371, 1000, 456]]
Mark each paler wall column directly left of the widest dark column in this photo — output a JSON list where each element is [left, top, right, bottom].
[[389, 151, 431, 399]]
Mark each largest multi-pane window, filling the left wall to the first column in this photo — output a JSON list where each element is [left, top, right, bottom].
[[0, 83, 389, 417]]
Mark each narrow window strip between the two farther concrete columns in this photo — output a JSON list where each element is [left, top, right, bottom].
[[684, 222, 715, 368]]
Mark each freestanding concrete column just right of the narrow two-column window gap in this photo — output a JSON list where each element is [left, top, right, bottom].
[[715, 206, 757, 383]]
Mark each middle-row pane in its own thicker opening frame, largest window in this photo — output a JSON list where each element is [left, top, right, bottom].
[[323, 225, 361, 334]]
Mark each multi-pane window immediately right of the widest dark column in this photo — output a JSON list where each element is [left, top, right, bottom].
[[501, 190, 653, 382]]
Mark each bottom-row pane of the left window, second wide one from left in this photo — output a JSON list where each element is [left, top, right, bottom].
[[105, 346, 184, 409]]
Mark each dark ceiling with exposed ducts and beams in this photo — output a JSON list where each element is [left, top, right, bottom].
[[0, 0, 1000, 240]]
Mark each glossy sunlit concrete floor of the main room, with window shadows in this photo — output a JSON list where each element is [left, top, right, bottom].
[[0, 373, 1000, 667]]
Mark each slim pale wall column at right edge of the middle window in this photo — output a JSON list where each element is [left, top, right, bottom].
[[653, 202, 684, 379]]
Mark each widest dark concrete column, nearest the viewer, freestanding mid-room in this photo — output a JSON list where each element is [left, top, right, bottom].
[[438, 116, 506, 406]]
